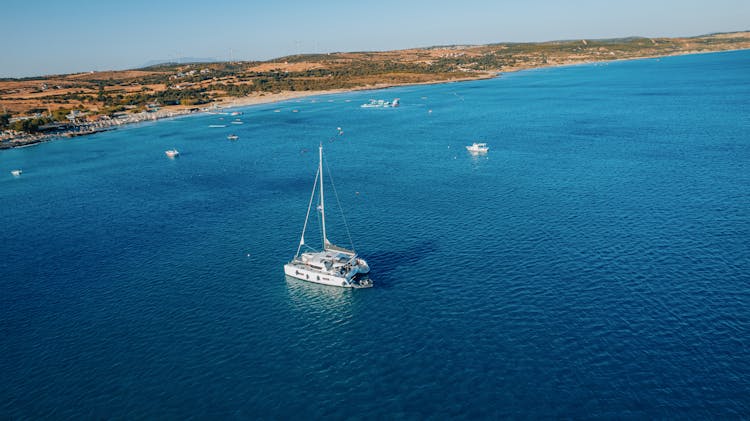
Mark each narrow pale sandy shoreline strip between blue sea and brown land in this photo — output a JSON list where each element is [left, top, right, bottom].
[[0, 48, 750, 150]]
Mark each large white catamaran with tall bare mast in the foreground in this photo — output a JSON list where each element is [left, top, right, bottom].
[[284, 145, 372, 288]]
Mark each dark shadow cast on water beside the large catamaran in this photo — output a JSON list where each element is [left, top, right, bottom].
[[364, 240, 438, 288]]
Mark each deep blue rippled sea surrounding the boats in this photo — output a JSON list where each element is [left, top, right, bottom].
[[0, 51, 750, 419]]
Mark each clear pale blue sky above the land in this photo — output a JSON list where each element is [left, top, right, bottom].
[[0, 0, 750, 77]]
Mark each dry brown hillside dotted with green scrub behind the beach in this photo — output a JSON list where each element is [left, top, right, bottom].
[[0, 32, 750, 132]]
